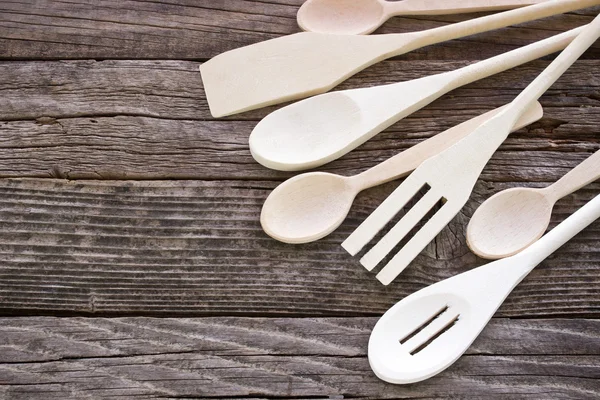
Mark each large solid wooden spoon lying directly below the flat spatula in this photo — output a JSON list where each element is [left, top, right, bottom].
[[250, 27, 583, 171]]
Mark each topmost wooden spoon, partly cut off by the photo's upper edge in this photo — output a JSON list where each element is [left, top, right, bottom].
[[297, 0, 546, 35]]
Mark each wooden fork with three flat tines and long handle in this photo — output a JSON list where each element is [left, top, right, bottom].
[[342, 15, 600, 285]]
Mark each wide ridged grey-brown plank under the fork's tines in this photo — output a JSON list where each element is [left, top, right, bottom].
[[0, 179, 600, 317]]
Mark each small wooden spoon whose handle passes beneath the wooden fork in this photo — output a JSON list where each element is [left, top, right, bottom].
[[260, 103, 543, 243]]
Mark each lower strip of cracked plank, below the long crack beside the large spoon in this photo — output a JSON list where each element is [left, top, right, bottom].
[[0, 108, 600, 182]]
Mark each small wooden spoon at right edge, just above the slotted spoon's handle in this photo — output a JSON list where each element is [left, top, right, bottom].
[[467, 148, 600, 260]]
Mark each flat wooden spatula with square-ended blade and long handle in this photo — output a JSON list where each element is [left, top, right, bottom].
[[200, 0, 600, 117]]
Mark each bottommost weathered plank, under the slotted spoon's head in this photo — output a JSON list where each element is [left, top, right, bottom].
[[0, 317, 600, 400]]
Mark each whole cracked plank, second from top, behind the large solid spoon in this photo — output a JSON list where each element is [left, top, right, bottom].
[[0, 60, 600, 180]]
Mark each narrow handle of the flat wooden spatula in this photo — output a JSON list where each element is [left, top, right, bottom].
[[404, 0, 600, 52]]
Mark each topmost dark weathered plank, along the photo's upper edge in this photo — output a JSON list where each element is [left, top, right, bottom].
[[0, 0, 600, 60]]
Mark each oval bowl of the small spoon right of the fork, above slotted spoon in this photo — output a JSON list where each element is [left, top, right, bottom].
[[467, 188, 554, 260]]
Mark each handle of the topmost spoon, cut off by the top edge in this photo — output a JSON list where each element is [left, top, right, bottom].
[[384, 0, 548, 15]]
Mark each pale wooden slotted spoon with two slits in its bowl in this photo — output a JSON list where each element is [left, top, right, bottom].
[[368, 196, 600, 384]]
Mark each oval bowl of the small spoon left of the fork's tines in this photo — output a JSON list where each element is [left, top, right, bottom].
[[260, 172, 358, 244]]
